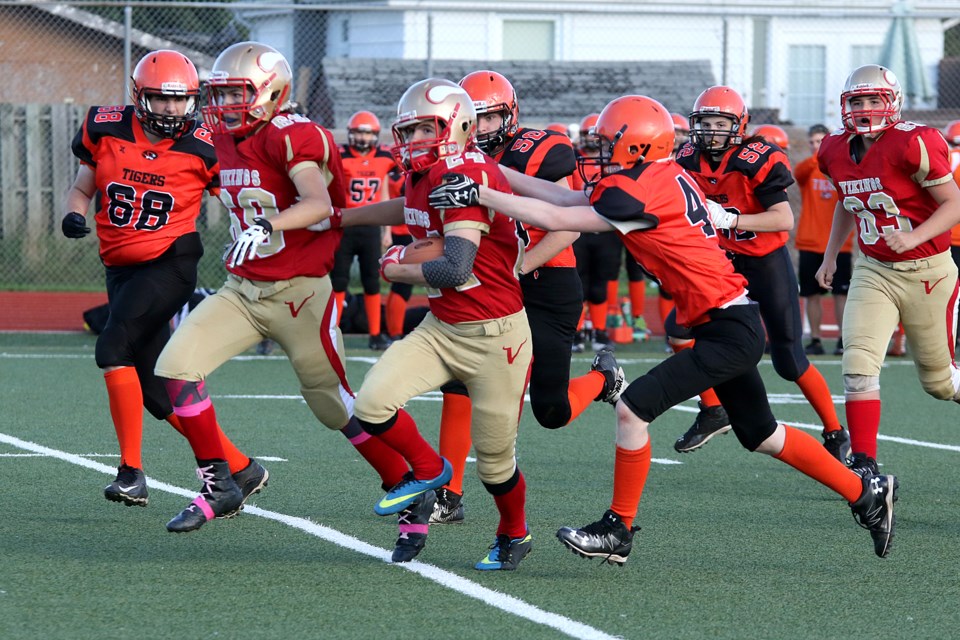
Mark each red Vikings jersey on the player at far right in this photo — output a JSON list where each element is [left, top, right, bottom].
[[817, 122, 953, 262]]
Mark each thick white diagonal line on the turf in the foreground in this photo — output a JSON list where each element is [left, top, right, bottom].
[[0, 433, 616, 640]]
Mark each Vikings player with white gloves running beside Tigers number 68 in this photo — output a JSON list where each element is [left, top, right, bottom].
[[156, 42, 406, 532]]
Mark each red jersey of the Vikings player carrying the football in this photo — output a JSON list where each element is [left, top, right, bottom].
[[403, 151, 523, 324]]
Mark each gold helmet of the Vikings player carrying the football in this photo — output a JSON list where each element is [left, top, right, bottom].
[[392, 78, 477, 172]]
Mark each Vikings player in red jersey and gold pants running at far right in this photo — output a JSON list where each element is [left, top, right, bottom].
[[817, 64, 960, 471]]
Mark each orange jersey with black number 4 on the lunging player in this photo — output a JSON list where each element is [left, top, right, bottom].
[[590, 160, 747, 327]]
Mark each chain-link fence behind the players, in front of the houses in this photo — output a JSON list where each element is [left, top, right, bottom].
[[0, 0, 960, 290]]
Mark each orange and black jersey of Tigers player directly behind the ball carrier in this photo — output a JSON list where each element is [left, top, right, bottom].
[[495, 128, 577, 267]]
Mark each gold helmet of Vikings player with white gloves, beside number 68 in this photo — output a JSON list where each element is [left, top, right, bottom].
[[203, 42, 293, 138]]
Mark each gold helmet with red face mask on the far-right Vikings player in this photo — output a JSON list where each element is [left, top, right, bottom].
[[840, 64, 903, 137]]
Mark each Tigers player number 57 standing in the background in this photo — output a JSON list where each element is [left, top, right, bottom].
[[330, 111, 396, 351]]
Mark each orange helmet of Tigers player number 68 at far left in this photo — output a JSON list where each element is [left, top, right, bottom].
[[130, 49, 200, 138]]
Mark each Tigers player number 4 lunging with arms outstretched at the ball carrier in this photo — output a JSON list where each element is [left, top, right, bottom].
[[430, 96, 896, 564]]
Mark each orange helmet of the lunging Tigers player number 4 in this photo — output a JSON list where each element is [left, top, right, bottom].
[[577, 96, 675, 184]]
